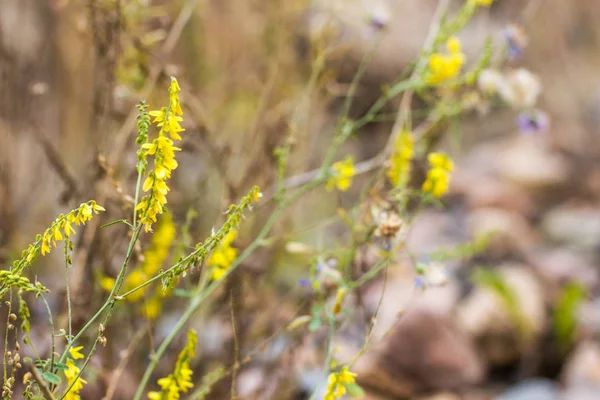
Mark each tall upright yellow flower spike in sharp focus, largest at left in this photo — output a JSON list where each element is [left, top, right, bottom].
[[136, 78, 184, 232]]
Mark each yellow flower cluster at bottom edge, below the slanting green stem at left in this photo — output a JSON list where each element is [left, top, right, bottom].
[[148, 330, 198, 400]]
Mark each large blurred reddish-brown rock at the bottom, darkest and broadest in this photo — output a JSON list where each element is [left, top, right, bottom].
[[355, 309, 484, 397]]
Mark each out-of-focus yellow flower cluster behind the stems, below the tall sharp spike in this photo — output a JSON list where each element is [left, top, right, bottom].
[[100, 213, 176, 319]]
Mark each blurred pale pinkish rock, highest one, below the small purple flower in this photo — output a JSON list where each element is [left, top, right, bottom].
[[499, 136, 569, 190]]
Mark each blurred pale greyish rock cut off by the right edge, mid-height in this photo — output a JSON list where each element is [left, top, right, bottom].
[[542, 206, 600, 251]]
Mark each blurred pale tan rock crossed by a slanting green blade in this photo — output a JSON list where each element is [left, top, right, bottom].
[[457, 265, 546, 365]]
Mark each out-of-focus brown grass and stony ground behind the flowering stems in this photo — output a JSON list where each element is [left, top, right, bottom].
[[0, 0, 600, 400]]
